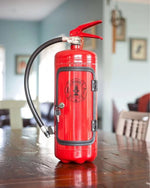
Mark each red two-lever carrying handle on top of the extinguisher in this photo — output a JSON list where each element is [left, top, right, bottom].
[[70, 20, 103, 40]]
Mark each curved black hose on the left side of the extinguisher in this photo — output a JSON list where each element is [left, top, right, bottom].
[[24, 37, 63, 137]]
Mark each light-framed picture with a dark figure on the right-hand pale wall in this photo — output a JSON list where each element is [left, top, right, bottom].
[[130, 38, 147, 61]]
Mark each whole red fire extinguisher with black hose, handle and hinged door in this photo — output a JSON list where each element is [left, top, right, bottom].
[[24, 20, 102, 163]]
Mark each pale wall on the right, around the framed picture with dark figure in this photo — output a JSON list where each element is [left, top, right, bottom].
[[112, 2, 150, 110]]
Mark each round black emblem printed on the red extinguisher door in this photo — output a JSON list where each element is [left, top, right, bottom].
[[65, 78, 87, 103]]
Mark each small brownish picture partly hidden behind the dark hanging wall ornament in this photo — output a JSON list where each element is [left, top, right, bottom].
[[116, 18, 126, 41]]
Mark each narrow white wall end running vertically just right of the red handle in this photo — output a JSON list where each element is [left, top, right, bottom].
[[100, 0, 112, 132]]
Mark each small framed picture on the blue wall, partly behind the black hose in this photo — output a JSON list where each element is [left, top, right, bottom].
[[16, 55, 30, 75]]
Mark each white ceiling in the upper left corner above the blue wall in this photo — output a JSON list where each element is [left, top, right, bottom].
[[0, 0, 66, 21]]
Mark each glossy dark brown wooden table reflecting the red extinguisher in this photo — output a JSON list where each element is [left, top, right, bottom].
[[0, 128, 150, 188]]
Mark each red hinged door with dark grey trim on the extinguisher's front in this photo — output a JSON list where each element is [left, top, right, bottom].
[[55, 67, 96, 146]]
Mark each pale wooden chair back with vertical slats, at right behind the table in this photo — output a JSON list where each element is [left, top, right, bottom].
[[116, 111, 150, 141]]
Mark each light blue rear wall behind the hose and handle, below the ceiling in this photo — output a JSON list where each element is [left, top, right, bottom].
[[0, 0, 103, 129]]
